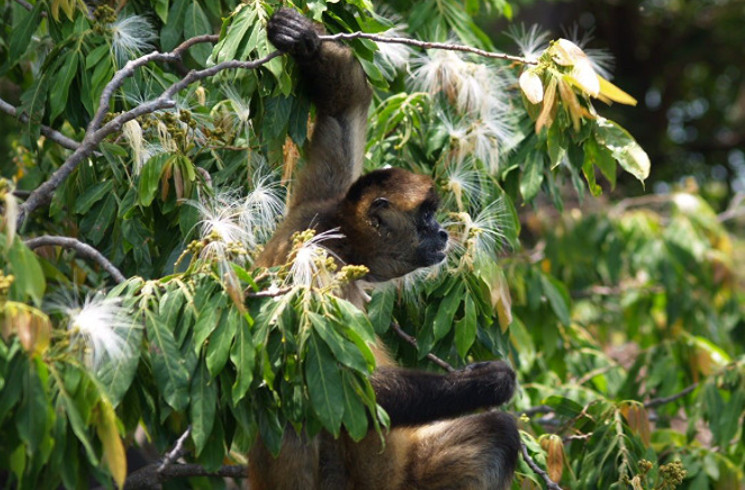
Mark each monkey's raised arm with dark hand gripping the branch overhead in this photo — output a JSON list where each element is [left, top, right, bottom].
[[267, 9, 372, 208]]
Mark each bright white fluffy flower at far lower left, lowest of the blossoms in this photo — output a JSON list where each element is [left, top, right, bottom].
[[54, 293, 140, 369]]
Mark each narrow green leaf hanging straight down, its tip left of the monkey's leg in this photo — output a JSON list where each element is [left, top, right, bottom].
[[189, 362, 218, 457]]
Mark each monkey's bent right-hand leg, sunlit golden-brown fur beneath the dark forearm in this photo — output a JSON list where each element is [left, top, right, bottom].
[[400, 412, 520, 490]]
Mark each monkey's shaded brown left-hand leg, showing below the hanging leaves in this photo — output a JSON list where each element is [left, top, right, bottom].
[[248, 427, 319, 490]]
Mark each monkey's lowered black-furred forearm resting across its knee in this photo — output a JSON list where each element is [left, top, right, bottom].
[[371, 361, 515, 426]]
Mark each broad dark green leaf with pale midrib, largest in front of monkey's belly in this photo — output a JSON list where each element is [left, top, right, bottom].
[[305, 334, 344, 436]]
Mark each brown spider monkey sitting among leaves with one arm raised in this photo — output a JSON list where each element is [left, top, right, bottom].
[[249, 9, 519, 490]]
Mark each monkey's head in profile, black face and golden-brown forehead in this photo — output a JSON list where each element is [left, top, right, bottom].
[[339, 168, 448, 281]]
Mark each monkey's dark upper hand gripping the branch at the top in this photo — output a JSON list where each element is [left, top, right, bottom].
[[266, 8, 321, 61]]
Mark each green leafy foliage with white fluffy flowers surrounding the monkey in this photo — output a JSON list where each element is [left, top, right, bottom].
[[0, 0, 745, 488]]
